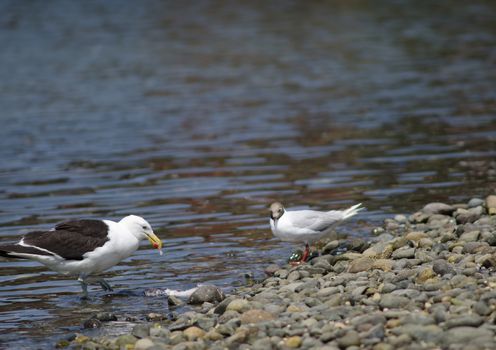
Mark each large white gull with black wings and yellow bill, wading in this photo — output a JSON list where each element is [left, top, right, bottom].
[[0, 215, 162, 297]]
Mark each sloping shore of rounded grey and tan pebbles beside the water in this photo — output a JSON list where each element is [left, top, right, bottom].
[[62, 196, 496, 350]]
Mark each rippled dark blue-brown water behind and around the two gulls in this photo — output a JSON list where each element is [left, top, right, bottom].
[[0, 1, 496, 348]]
